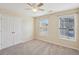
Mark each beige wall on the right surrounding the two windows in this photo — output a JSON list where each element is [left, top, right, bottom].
[[35, 8, 79, 50]]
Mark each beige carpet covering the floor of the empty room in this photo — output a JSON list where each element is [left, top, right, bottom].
[[0, 40, 79, 55]]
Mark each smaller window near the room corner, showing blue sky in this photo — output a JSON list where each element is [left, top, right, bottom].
[[40, 19, 48, 35]]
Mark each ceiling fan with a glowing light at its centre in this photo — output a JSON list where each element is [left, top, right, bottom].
[[25, 3, 44, 12]]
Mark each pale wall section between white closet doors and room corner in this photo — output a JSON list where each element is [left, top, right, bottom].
[[22, 16, 33, 42]]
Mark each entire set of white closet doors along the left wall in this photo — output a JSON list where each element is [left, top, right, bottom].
[[0, 16, 22, 49]]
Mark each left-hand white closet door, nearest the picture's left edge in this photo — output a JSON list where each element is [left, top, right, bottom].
[[1, 16, 14, 49]]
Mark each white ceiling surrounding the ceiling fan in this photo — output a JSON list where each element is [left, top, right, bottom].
[[0, 3, 79, 17]]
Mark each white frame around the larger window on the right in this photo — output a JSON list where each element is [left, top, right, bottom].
[[58, 14, 77, 41]]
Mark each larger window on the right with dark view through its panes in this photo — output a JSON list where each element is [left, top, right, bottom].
[[59, 15, 76, 40]]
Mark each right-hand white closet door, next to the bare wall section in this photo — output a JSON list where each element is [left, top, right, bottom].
[[14, 17, 23, 44]]
